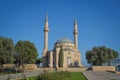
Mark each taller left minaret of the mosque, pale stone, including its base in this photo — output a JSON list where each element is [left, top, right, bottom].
[[42, 15, 49, 67]]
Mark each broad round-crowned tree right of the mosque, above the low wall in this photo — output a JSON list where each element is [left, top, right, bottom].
[[86, 46, 119, 65]]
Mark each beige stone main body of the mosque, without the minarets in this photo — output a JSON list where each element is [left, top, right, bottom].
[[53, 38, 81, 68]]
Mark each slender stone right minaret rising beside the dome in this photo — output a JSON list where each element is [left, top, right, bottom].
[[73, 19, 78, 48]]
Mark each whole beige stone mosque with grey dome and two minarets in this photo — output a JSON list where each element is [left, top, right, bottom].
[[42, 16, 82, 68]]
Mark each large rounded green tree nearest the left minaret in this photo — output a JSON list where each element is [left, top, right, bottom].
[[15, 40, 38, 64]]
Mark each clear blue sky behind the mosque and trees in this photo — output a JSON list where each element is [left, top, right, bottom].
[[0, 0, 120, 66]]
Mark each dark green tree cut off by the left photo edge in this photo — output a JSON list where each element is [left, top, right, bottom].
[[0, 37, 14, 65]]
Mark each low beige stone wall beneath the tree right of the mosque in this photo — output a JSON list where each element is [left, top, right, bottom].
[[92, 66, 115, 71]]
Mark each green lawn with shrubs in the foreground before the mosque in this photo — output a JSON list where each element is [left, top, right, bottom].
[[20, 71, 87, 80]]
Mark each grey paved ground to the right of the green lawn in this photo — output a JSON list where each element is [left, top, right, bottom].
[[83, 71, 120, 80]]
